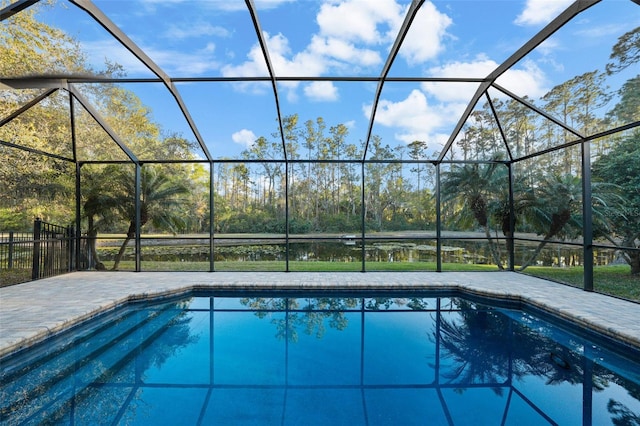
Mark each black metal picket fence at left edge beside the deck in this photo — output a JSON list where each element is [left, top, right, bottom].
[[0, 219, 76, 280]]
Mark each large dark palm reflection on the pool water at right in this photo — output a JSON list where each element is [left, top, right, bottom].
[[434, 299, 604, 393]]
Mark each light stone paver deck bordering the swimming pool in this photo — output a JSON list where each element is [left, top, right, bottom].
[[0, 272, 640, 357]]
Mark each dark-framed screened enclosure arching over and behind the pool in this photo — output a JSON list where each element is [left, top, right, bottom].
[[0, 0, 640, 298]]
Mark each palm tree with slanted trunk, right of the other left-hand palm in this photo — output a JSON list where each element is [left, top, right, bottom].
[[112, 167, 189, 271]]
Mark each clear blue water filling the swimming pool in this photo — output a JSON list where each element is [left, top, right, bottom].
[[0, 293, 640, 426]]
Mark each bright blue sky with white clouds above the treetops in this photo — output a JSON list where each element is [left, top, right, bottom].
[[32, 0, 640, 158]]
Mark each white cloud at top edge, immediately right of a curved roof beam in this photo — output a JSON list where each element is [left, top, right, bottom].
[[399, 2, 453, 64]]
